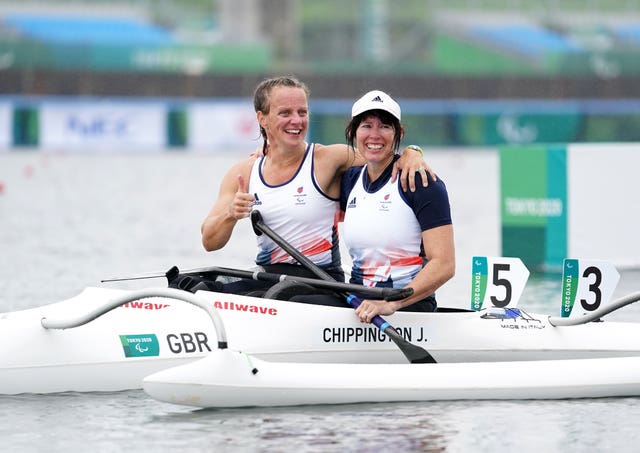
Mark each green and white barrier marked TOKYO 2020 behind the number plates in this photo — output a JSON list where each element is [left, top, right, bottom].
[[499, 143, 640, 270]]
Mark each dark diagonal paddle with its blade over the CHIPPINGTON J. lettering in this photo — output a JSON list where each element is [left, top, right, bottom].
[[251, 210, 436, 363]]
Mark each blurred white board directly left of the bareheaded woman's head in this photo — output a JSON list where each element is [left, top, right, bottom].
[[187, 101, 262, 152]]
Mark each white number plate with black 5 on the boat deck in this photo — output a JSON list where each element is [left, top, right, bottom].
[[471, 256, 529, 310]]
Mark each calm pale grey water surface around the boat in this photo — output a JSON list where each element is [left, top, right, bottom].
[[0, 151, 640, 452]]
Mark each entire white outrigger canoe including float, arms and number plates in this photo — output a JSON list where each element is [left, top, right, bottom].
[[0, 212, 640, 400]]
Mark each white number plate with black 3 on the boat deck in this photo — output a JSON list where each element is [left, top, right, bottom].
[[560, 258, 620, 318]]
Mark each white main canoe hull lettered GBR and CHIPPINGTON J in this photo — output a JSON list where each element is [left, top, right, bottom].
[[0, 288, 640, 394]]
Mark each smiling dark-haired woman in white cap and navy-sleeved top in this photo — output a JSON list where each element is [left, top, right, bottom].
[[340, 90, 455, 322]]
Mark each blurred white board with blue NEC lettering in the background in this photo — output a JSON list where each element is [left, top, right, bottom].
[[40, 102, 166, 151]]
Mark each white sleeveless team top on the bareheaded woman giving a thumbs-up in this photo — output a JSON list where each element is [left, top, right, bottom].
[[249, 144, 340, 266]]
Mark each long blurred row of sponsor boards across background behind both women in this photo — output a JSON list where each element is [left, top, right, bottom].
[[8, 98, 640, 152]]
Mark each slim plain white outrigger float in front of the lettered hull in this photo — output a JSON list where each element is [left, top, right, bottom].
[[143, 350, 640, 408]]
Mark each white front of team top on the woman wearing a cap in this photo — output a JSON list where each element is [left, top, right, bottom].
[[342, 166, 423, 288]]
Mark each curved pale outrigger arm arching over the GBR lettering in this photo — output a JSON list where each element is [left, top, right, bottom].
[[40, 288, 228, 349]]
